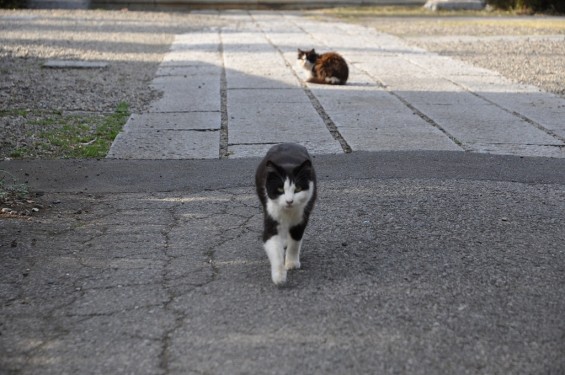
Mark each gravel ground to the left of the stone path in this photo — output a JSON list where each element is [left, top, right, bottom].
[[0, 10, 225, 159]]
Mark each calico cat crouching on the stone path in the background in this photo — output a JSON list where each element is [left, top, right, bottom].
[[298, 49, 349, 85]]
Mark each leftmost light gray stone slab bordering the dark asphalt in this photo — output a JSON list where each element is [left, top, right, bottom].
[[107, 129, 220, 160]]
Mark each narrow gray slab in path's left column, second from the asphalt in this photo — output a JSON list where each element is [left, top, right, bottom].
[[125, 111, 222, 131]]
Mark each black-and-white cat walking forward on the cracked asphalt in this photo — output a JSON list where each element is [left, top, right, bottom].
[[255, 143, 316, 285]]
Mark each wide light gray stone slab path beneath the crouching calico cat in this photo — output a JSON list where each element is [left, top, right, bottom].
[[108, 12, 565, 159]]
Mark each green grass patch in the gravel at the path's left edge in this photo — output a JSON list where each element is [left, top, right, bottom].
[[10, 102, 130, 159]]
